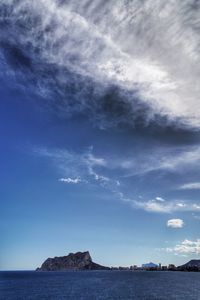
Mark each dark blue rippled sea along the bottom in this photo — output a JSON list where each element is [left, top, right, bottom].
[[0, 271, 200, 300]]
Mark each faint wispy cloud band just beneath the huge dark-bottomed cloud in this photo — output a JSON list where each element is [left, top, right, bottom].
[[37, 145, 200, 180]]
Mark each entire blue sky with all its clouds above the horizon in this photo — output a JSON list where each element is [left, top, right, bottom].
[[0, 0, 200, 270]]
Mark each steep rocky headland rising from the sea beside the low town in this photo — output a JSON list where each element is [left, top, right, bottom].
[[37, 251, 109, 271]]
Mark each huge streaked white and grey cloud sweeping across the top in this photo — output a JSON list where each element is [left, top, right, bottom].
[[1, 0, 200, 128]]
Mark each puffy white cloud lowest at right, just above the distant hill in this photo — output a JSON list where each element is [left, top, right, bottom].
[[166, 239, 200, 254]]
